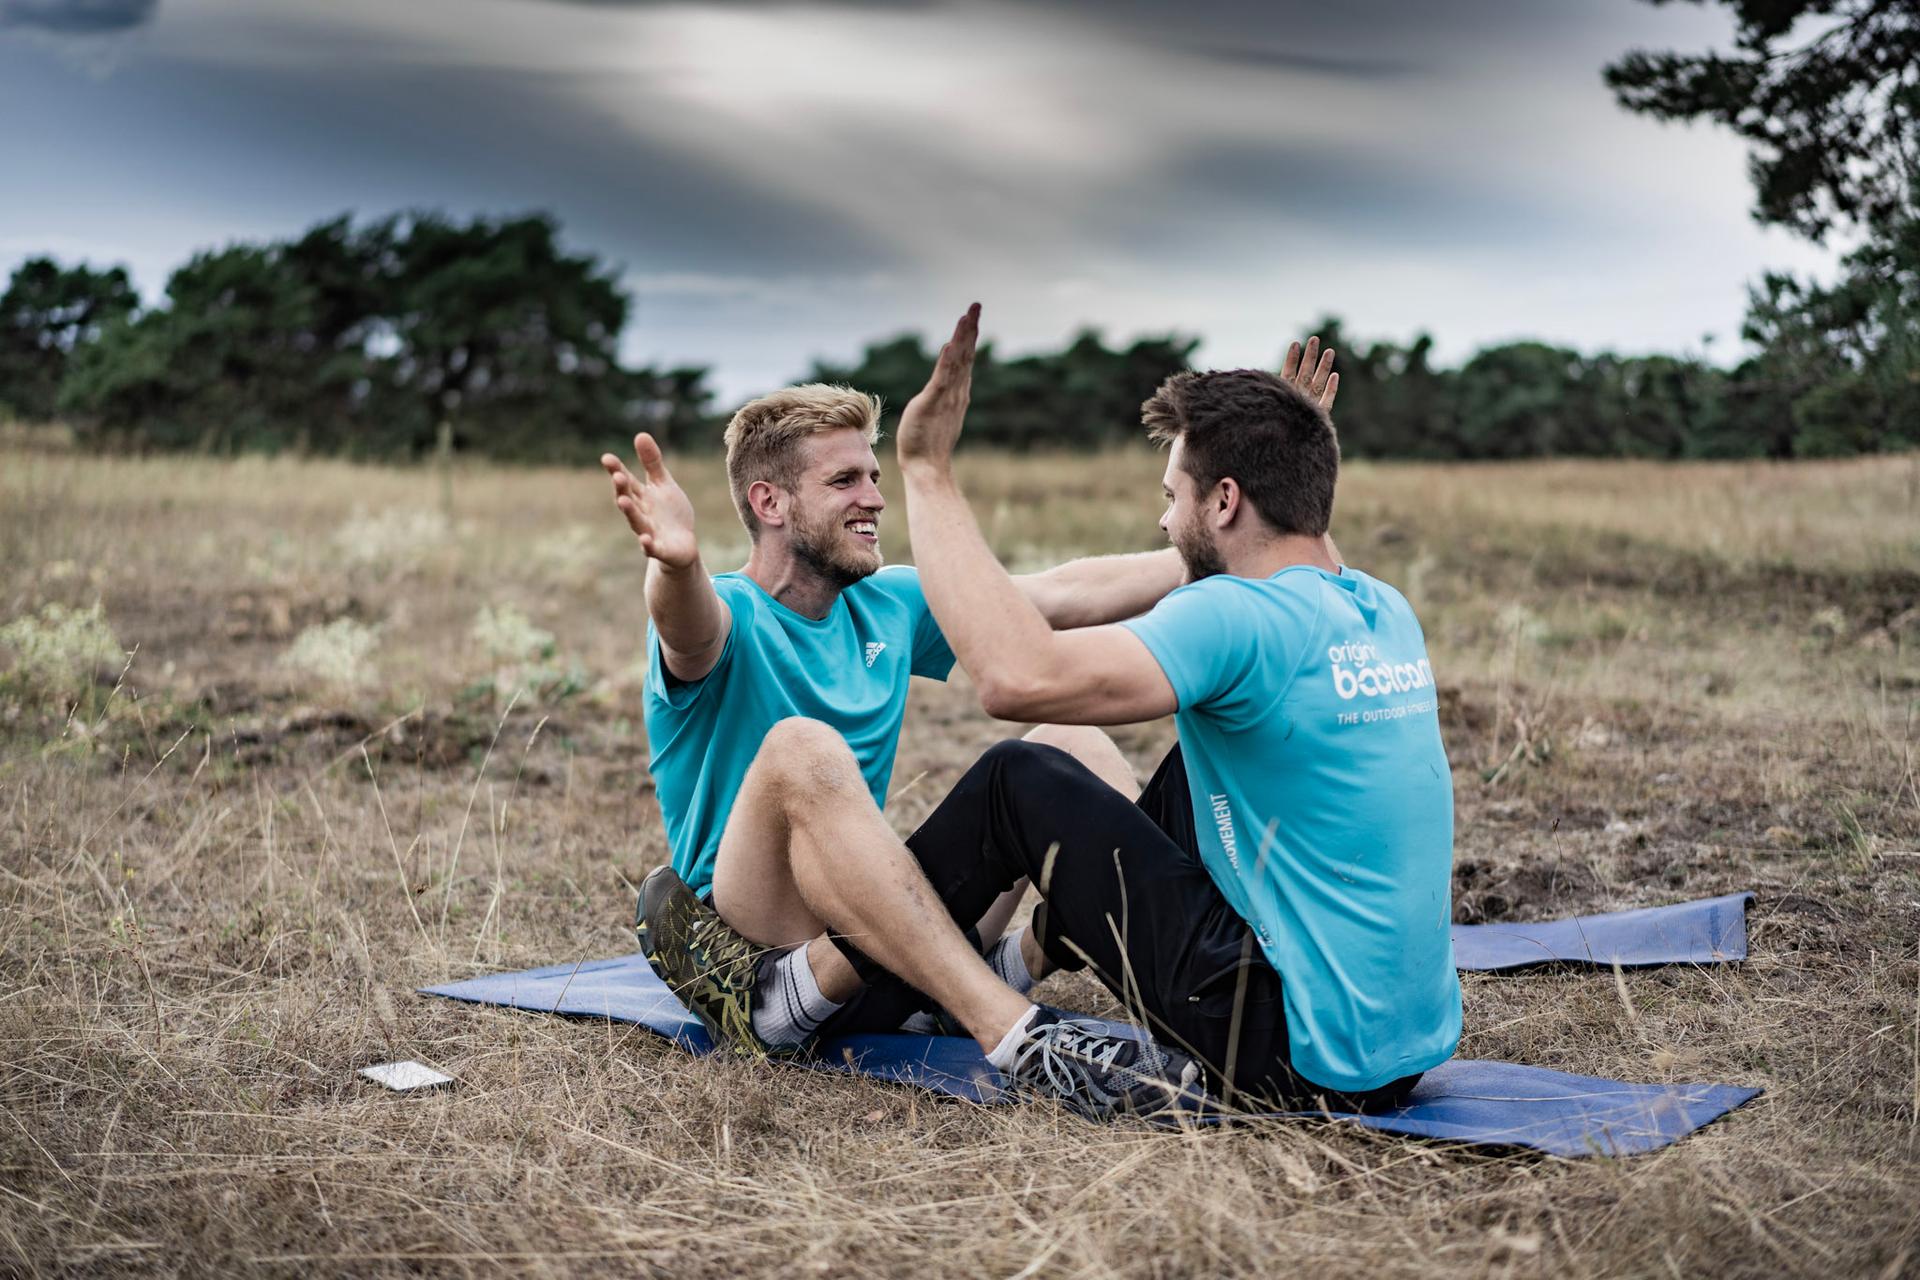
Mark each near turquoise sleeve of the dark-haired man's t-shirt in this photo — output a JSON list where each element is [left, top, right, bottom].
[[1119, 578, 1279, 720]]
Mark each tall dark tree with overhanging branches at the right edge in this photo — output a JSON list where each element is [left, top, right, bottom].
[[1605, 0, 1920, 457]]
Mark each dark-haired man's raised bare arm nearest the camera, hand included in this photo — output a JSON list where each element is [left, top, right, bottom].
[[899, 305, 1177, 723]]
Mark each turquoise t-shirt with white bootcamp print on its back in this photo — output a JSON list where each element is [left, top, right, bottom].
[[1121, 564, 1459, 1090]]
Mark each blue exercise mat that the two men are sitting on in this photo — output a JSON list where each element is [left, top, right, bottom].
[[424, 956, 1761, 1155]]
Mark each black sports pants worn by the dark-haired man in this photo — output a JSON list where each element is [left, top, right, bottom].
[[822, 741, 1419, 1111]]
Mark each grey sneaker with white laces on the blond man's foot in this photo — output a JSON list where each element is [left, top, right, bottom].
[[1006, 1007, 1206, 1121]]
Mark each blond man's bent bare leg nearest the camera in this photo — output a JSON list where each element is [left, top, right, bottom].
[[714, 718, 1029, 1050]]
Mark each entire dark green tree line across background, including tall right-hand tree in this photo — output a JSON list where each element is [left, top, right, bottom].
[[0, 0, 1920, 461]]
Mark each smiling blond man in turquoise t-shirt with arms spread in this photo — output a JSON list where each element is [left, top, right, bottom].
[[601, 384, 1183, 1074]]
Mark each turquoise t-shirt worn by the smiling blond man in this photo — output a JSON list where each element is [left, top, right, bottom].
[[647, 564, 954, 892]]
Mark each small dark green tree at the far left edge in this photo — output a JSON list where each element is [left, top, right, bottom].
[[0, 257, 140, 422]]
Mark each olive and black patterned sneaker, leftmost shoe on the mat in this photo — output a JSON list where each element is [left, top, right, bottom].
[[634, 867, 812, 1057]]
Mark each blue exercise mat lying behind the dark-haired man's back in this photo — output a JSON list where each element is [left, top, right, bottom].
[[1453, 892, 1753, 973]]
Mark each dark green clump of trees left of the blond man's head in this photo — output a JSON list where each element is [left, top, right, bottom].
[[0, 213, 712, 461]]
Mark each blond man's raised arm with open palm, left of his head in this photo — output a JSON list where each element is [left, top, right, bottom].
[[601, 432, 733, 681]]
